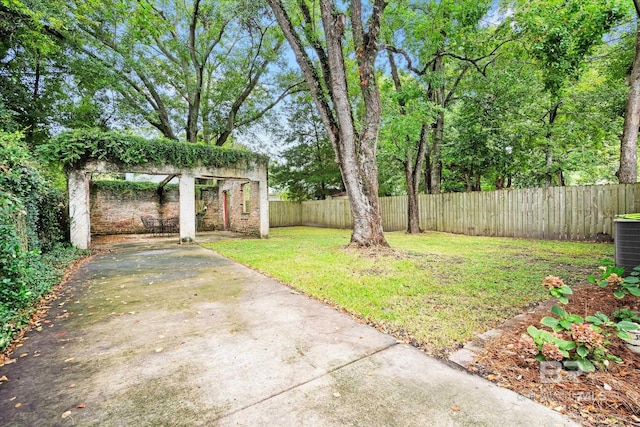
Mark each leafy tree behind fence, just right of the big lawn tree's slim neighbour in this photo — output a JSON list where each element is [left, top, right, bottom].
[[387, 0, 506, 193]]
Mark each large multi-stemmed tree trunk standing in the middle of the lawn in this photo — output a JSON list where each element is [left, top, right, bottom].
[[267, 0, 388, 246]]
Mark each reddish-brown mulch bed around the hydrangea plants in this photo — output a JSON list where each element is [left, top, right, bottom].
[[469, 285, 640, 427]]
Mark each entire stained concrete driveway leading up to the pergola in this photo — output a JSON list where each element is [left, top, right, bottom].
[[0, 240, 572, 426]]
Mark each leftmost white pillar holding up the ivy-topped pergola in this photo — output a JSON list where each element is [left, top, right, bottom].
[[68, 170, 91, 249]]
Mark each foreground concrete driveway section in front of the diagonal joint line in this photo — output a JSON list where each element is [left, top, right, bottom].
[[220, 344, 570, 426]]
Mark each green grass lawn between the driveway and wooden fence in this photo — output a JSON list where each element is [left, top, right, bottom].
[[203, 227, 613, 356]]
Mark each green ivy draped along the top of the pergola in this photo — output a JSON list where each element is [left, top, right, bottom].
[[39, 129, 268, 170]]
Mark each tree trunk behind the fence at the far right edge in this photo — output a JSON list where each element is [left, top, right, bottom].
[[618, 18, 640, 184]]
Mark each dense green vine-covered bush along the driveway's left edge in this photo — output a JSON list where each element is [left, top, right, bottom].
[[0, 132, 80, 351]]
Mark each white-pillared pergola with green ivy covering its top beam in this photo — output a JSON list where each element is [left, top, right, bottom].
[[42, 130, 269, 249]]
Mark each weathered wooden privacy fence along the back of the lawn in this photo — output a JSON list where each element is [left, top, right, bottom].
[[269, 183, 640, 241]]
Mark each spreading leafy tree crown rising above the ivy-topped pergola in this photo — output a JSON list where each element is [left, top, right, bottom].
[[63, 0, 297, 145]]
